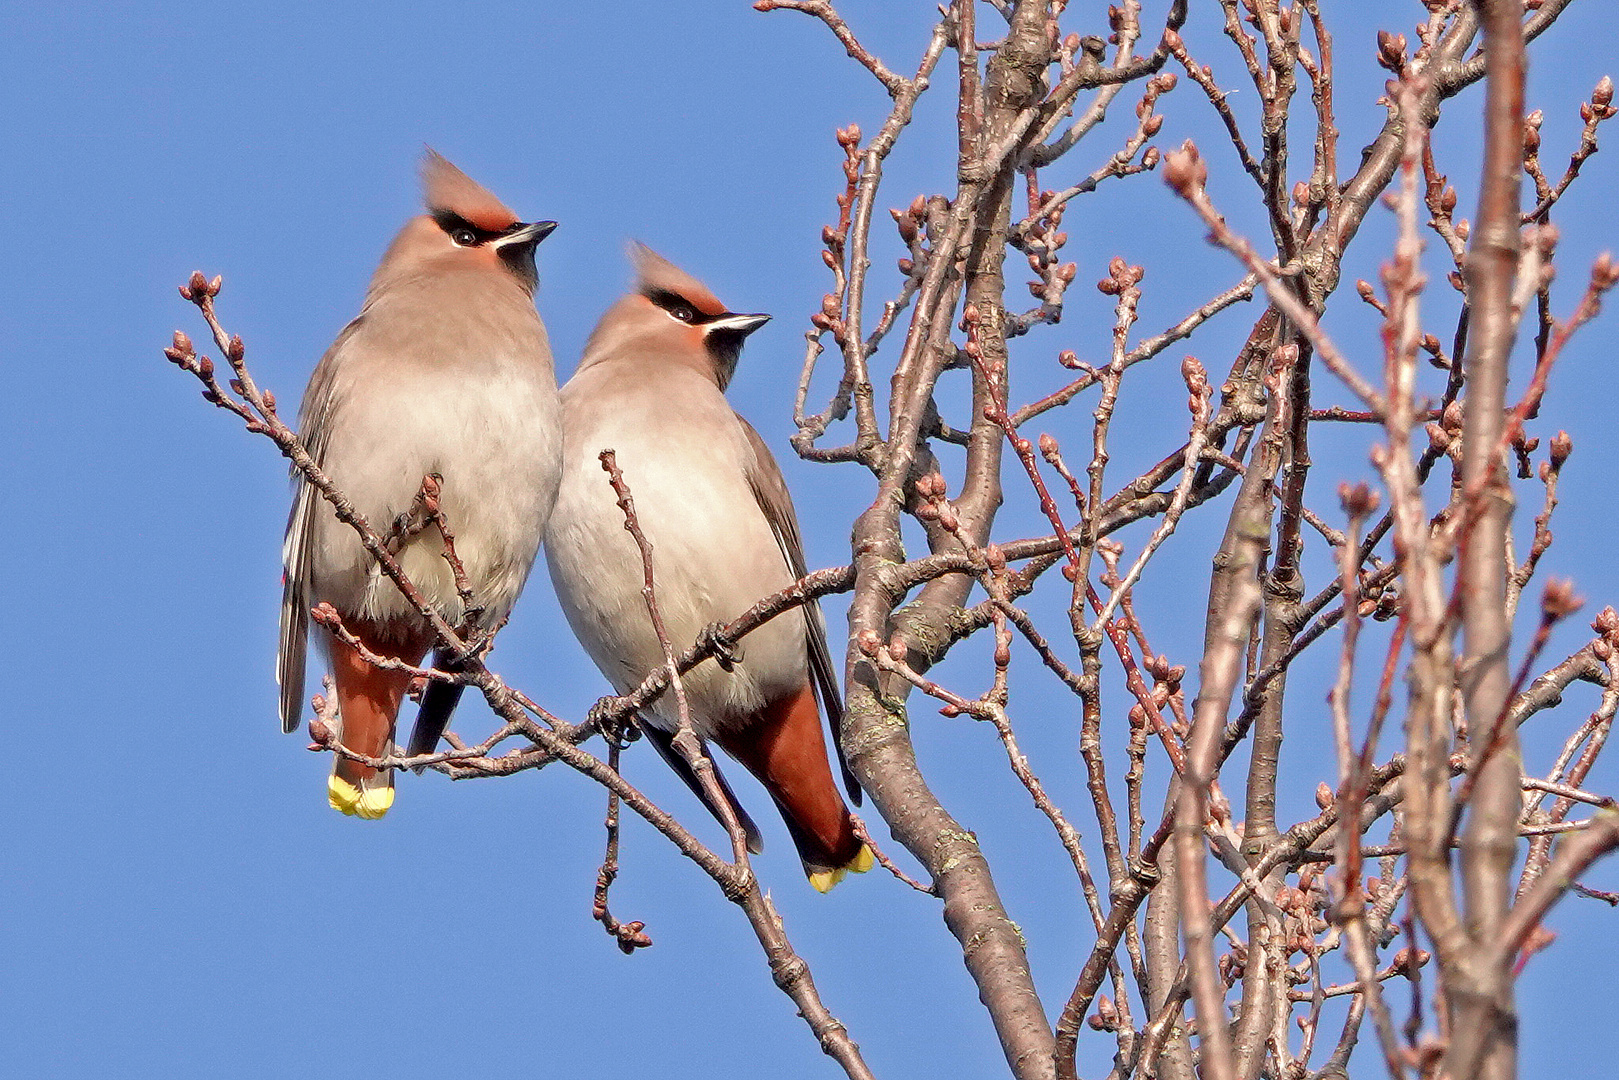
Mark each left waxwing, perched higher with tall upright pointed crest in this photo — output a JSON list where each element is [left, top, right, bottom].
[[277, 149, 562, 818]]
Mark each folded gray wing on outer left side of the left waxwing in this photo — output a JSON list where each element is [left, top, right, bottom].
[[275, 316, 364, 732]]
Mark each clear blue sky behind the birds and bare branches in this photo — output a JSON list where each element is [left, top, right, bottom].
[[0, 0, 1619, 1080]]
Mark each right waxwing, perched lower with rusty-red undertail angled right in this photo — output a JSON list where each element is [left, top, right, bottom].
[[546, 244, 873, 892]]
